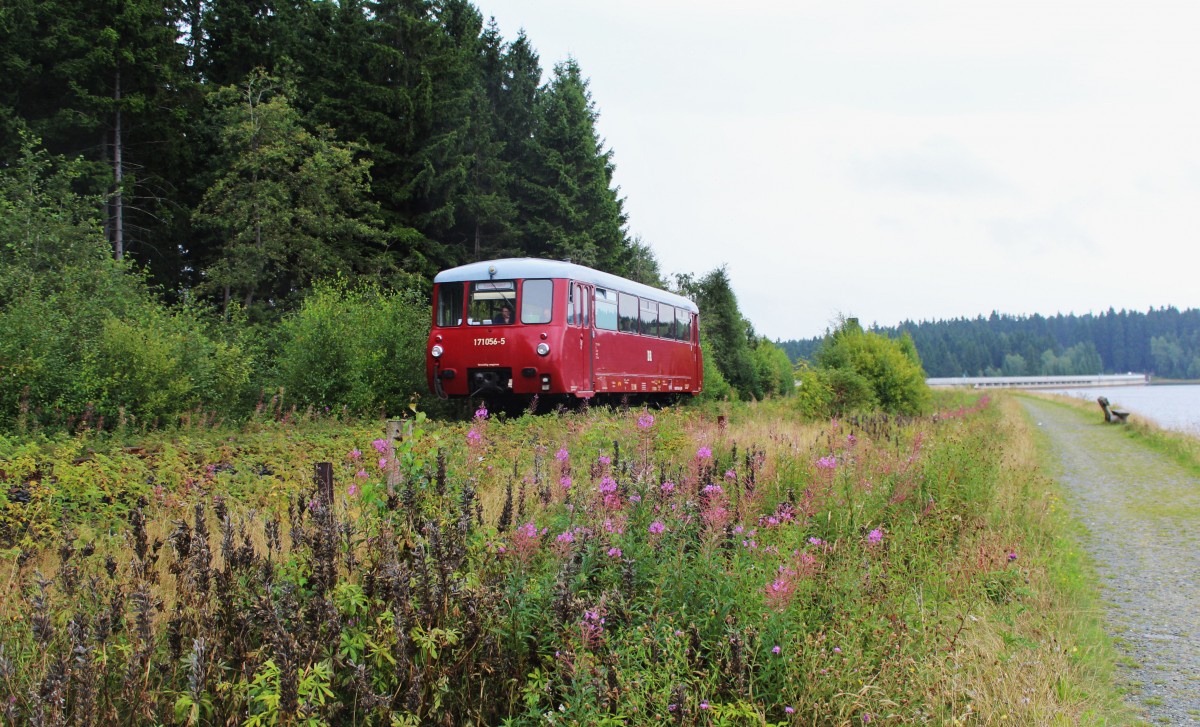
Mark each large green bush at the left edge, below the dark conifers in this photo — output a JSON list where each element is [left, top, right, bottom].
[[0, 139, 251, 428]]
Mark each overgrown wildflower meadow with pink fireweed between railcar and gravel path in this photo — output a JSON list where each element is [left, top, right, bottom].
[[0, 397, 1075, 726]]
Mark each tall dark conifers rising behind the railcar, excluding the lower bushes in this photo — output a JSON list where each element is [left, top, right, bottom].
[[0, 0, 659, 307]]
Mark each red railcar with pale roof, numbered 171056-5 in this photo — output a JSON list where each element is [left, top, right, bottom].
[[425, 258, 703, 405]]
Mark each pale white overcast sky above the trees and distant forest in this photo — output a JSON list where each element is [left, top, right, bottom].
[[476, 0, 1200, 338]]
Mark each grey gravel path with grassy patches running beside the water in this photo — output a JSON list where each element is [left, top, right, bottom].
[[1021, 397, 1200, 725]]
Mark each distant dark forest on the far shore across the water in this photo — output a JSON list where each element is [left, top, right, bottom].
[[778, 307, 1200, 379]]
